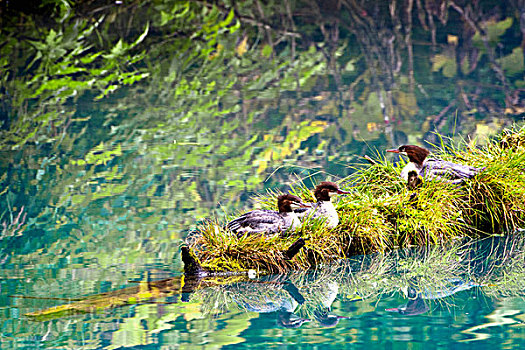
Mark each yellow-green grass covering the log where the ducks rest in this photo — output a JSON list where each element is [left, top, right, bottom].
[[188, 126, 525, 273]]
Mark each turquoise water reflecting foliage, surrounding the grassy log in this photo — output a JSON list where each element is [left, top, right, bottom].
[[0, 0, 525, 349]]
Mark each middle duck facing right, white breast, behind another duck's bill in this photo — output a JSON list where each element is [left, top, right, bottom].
[[295, 181, 351, 228]]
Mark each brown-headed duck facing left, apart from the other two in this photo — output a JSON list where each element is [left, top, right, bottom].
[[386, 145, 485, 184]]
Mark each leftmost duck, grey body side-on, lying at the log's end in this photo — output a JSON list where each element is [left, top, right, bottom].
[[226, 194, 311, 237]]
